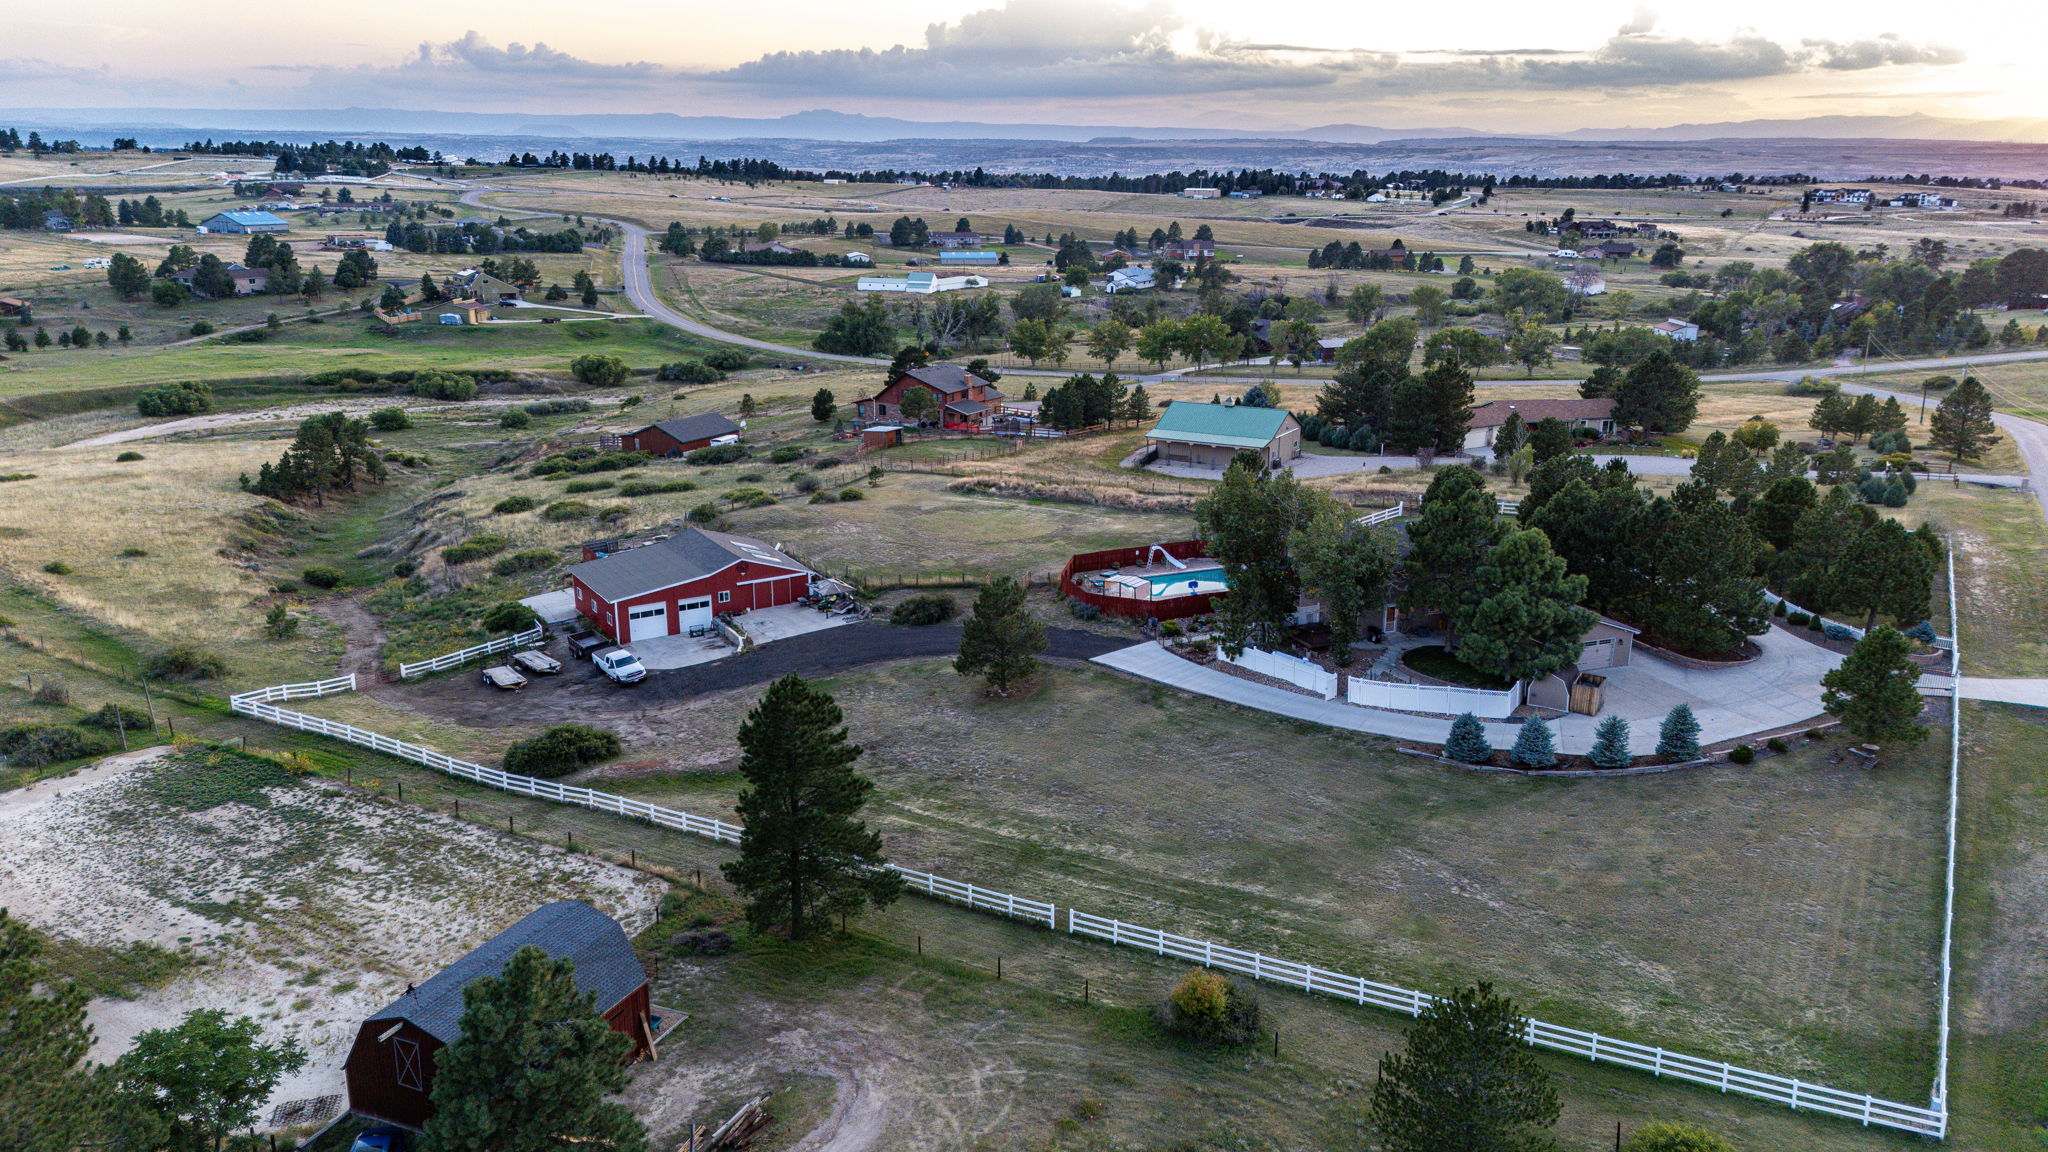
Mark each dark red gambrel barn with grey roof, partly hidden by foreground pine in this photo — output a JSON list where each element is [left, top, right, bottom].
[[346, 900, 653, 1127]]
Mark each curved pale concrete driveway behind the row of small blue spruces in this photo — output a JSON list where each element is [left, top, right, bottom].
[[1094, 627, 1851, 756]]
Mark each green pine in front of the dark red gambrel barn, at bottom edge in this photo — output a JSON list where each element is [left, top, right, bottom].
[[422, 947, 647, 1152]]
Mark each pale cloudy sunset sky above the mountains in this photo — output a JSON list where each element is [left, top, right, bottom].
[[0, 0, 2048, 131]]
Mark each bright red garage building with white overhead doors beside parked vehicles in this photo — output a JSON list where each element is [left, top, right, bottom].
[[569, 529, 811, 644]]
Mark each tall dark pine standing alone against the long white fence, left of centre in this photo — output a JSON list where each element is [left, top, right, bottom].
[[719, 674, 903, 939]]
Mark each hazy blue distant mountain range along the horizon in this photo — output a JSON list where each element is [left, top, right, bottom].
[[12, 109, 2048, 146]]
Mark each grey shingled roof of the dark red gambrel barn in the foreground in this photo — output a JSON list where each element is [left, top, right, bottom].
[[371, 900, 647, 1043]]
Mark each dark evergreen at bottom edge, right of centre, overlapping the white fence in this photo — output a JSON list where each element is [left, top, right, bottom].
[[1370, 984, 1559, 1152]]
